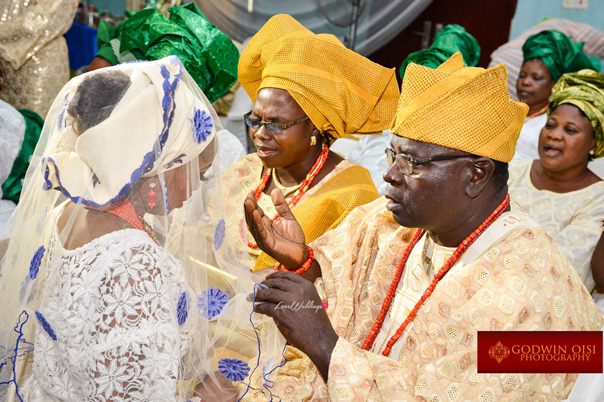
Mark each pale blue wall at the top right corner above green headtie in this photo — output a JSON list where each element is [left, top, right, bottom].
[[510, 0, 604, 40]]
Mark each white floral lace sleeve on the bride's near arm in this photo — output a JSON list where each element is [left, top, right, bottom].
[[89, 240, 181, 401]]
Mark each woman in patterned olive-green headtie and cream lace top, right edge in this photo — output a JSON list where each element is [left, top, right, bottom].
[[508, 70, 604, 292]]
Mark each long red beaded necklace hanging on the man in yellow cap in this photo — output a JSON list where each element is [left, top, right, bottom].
[[362, 195, 510, 356]]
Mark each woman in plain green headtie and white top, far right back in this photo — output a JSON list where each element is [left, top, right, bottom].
[[514, 30, 600, 159]]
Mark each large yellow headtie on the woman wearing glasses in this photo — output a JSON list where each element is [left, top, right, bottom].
[[239, 14, 399, 138]]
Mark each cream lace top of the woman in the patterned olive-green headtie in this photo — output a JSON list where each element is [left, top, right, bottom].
[[508, 159, 604, 292]]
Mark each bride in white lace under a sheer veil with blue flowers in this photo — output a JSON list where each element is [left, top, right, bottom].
[[0, 57, 283, 402]]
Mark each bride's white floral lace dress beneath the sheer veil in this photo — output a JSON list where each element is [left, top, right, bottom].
[[21, 229, 189, 402]]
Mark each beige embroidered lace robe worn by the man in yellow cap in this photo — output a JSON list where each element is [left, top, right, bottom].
[[247, 198, 604, 402]]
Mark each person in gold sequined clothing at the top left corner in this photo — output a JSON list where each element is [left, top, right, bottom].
[[0, 0, 78, 118]]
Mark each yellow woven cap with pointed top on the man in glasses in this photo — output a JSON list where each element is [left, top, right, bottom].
[[390, 53, 529, 163]]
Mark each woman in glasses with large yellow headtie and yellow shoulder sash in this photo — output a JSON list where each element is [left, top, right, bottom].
[[223, 15, 399, 274]]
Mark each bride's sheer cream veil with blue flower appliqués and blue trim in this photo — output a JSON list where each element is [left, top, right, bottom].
[[0, 56, 285, 401]]
